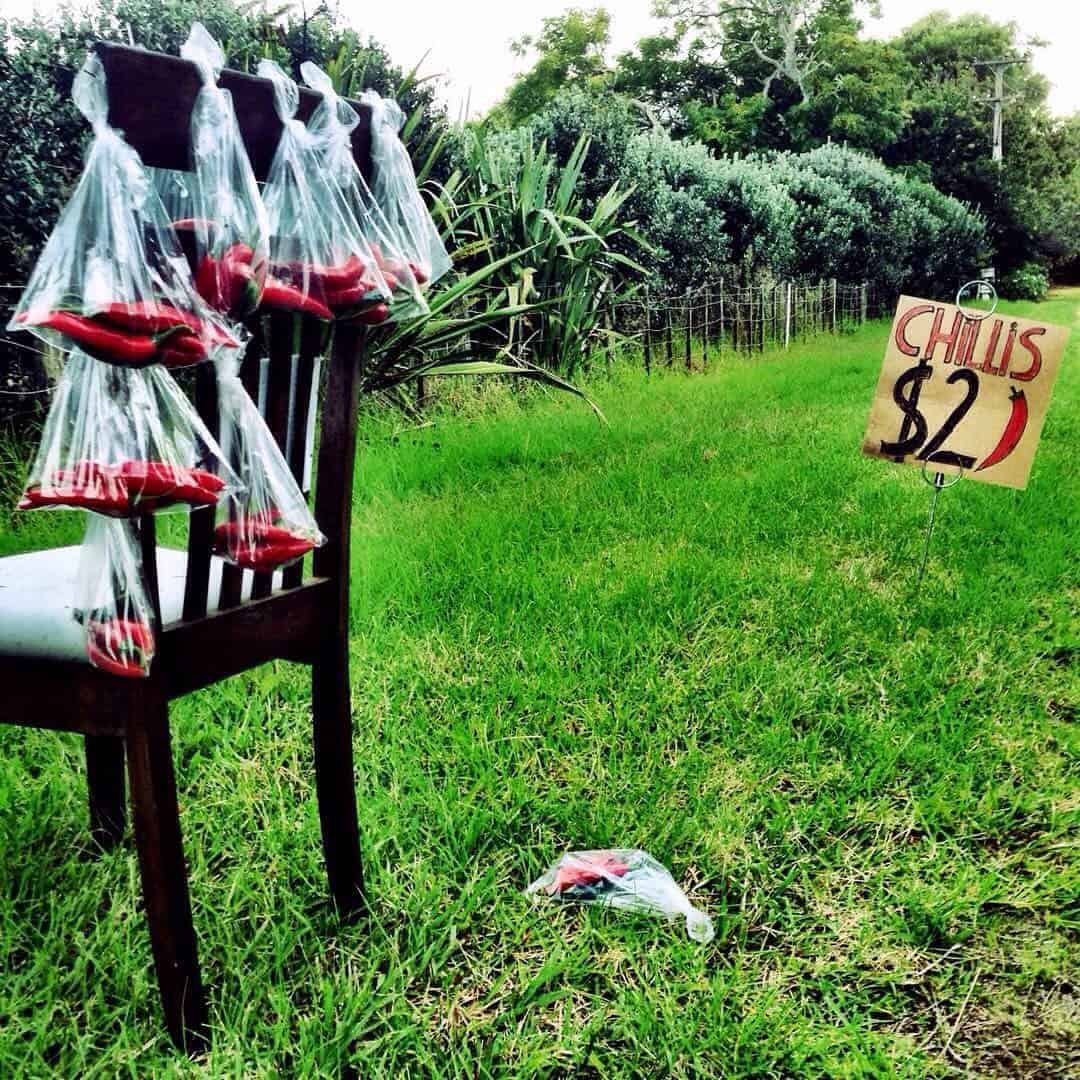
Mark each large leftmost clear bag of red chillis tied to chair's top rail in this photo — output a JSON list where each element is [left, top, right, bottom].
[[8, 53, 238, 367]]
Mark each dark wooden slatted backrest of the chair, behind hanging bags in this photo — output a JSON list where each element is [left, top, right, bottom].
[[95, 43, 372, 620]]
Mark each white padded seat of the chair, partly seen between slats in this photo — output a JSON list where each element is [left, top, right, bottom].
[[0, 545, 280, 660]]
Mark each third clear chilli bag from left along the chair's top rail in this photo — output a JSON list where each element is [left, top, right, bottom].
[[258, 59, 390, 322]]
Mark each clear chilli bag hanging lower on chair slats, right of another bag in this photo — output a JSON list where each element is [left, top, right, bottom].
[[214, 354, 326, 571]]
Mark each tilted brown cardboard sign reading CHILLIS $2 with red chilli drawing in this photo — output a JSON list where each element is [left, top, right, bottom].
[[863, 296, 1069, 488]]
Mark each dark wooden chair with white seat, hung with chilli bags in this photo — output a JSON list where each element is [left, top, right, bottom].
[[0, 45, 369, 1051]]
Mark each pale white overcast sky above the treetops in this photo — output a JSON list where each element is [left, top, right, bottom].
[[6, 0, 1080, 113]]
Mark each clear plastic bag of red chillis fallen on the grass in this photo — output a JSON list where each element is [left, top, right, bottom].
[[526, 848, 715, 945]]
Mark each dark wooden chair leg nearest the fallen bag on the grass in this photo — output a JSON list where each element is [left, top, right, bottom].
[[311, 639, 364, 917]]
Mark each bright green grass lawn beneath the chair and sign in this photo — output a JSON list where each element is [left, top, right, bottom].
[[0, 292, 1080, 1078]]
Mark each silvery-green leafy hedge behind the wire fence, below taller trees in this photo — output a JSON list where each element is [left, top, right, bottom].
[[522, 93, 987, 296]]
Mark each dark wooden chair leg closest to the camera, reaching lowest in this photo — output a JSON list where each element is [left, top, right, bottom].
[[127, 685, 210, 1053]]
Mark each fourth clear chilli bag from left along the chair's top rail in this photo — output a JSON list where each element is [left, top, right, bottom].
[[300, 60, 428, 322]]
